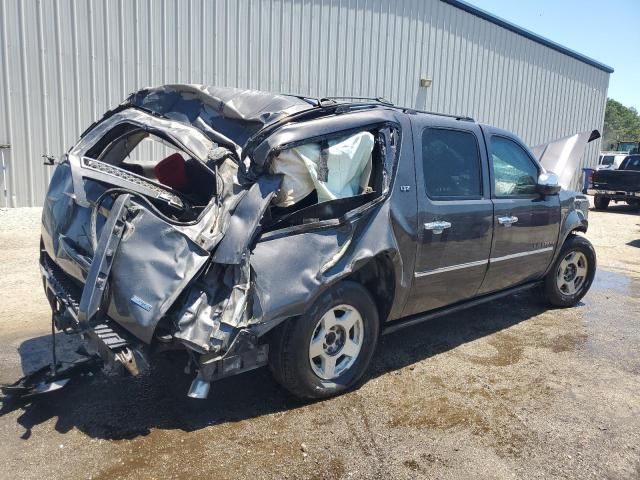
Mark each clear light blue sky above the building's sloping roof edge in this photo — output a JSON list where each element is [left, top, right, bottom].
[[466, 0, 640, 111]]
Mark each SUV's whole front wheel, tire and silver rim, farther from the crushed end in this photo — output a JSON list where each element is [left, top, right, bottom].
[[544, 234, 596, 308]]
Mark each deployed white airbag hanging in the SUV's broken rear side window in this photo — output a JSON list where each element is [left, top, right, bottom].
[[271, 132, 374, 207]]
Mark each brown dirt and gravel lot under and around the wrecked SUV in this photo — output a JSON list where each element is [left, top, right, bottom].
[[0, 201, 640, 479]]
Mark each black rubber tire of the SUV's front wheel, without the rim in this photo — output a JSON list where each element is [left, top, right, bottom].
[[544, 234, 596, 308]]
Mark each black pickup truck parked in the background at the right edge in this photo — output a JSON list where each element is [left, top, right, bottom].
[[587, 154, 640, 210]]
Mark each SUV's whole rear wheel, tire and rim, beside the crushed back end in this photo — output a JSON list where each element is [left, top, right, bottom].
[[269, 281, 379, 399]]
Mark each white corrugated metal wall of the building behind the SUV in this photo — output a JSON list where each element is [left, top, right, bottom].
[[0, 0, 609, 206]]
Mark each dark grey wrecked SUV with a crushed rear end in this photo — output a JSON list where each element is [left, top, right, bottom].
[[33, 85, 596, 398]]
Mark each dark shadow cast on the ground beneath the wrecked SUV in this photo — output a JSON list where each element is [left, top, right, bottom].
[[0, 292, 546, 439]]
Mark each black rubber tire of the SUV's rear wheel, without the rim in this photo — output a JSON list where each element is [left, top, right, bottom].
[[269, 281, 380, 400]]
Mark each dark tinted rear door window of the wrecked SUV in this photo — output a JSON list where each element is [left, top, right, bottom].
[[422, 128, 482, 200]]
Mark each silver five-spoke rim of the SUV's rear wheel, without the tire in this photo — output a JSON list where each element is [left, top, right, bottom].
[[309, 305, 364, 380]]
